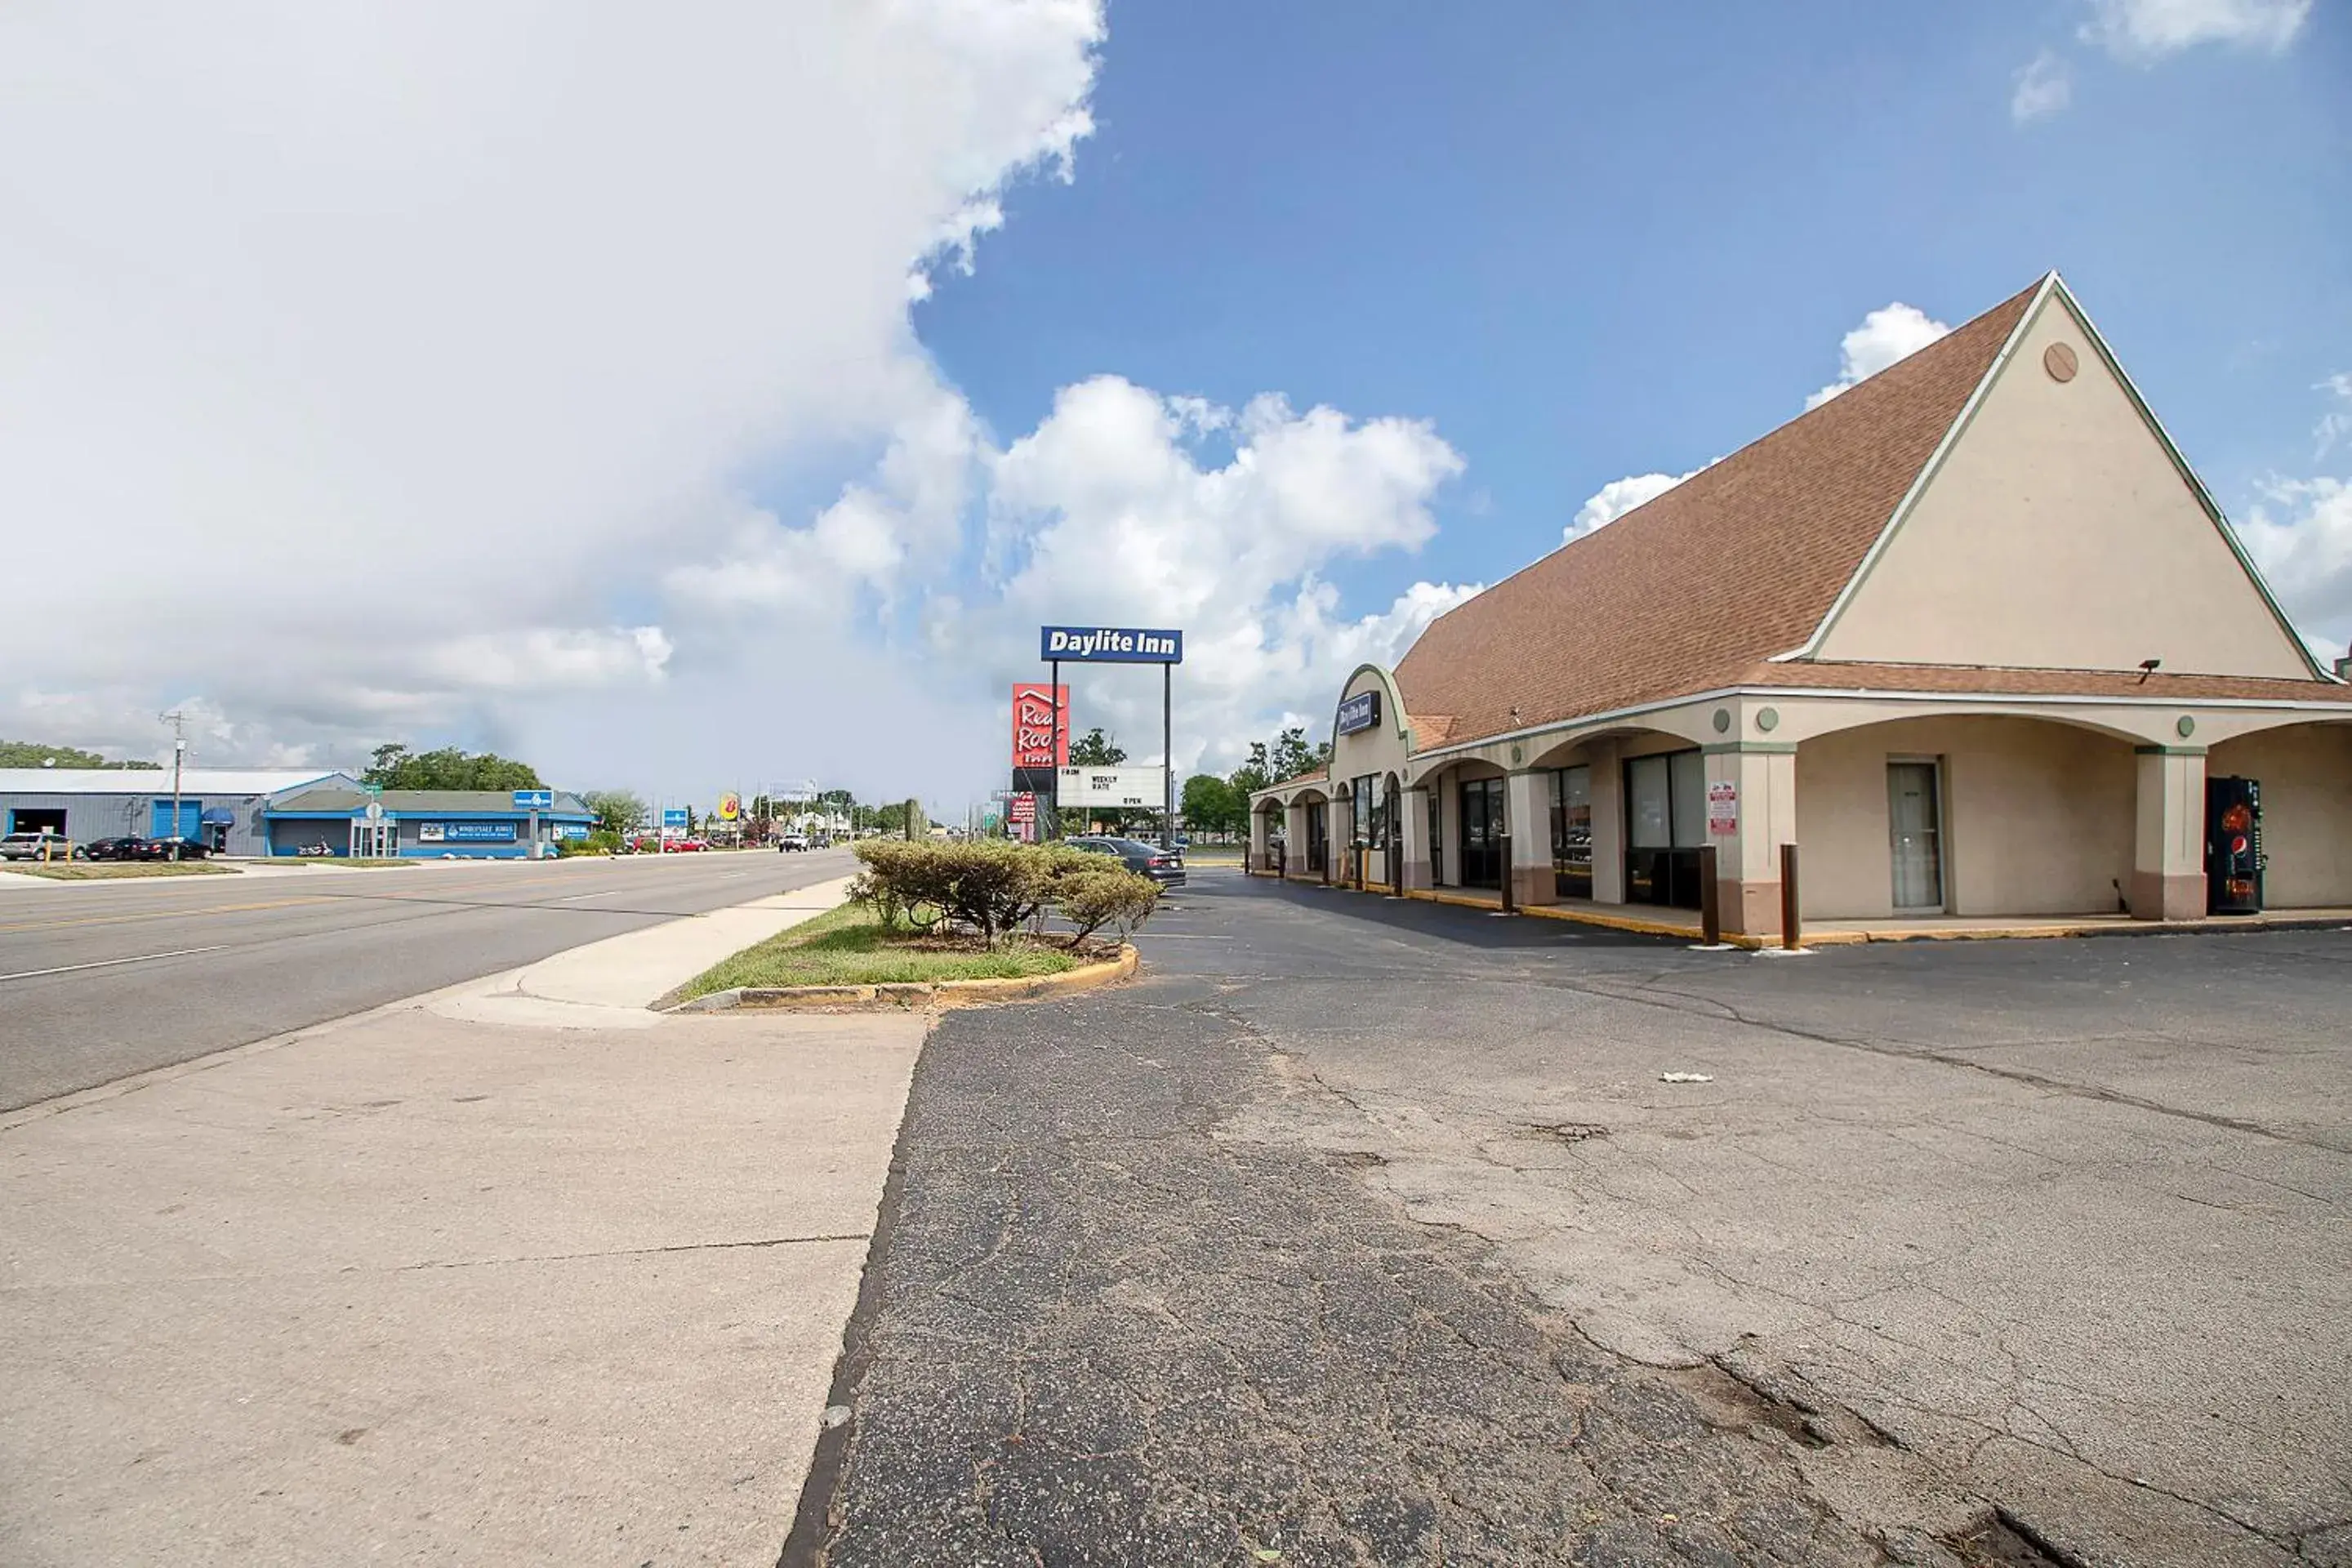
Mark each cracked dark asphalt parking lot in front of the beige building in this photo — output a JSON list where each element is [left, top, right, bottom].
[[808, 870, 2352, 1566]]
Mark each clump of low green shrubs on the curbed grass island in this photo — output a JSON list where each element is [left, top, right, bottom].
[[849, 840, 1160, 947]]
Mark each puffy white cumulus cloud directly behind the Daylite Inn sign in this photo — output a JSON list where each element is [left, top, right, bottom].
[[973, 376, 1477, 768]]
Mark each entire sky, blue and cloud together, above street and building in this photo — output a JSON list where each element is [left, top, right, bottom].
[[0, 0, 2352, 811]]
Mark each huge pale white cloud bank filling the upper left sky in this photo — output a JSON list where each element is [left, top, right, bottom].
[[0, 0, 1106, 776]]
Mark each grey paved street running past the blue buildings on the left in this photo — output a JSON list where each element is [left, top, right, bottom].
[[0, 849, 853, 1110]]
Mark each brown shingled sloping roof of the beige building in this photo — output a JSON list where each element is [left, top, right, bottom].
[[1397, 282, 2042, 747]]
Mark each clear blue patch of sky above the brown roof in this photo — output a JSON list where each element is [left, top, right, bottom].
[[915, 0, 2352, 611]]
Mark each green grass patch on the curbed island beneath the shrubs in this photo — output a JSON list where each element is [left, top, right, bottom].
[[675, 902, 1103, 1001]]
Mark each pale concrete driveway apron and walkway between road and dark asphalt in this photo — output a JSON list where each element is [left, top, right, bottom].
[[0, 879, 924, 1566]]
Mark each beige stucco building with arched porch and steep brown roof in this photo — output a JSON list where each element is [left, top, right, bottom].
[[1251, 273, 2352, 933]]
